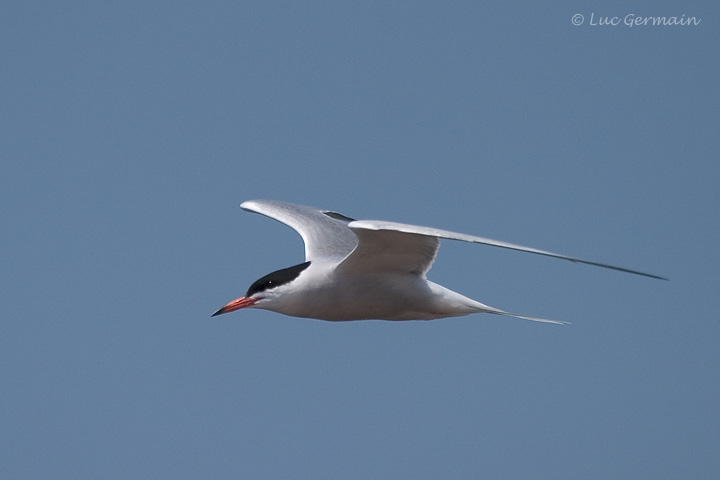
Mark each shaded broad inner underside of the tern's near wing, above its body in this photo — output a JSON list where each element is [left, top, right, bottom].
[[338, 226, 440, 278]]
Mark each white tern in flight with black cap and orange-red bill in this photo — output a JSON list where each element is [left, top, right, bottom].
[[212, 200, 665, 324]]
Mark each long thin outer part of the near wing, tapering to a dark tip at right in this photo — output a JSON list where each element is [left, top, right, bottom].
[[348, 220, 667, 280]]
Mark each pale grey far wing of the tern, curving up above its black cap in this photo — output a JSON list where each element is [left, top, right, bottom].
[[240, 200, 357, 261]]
